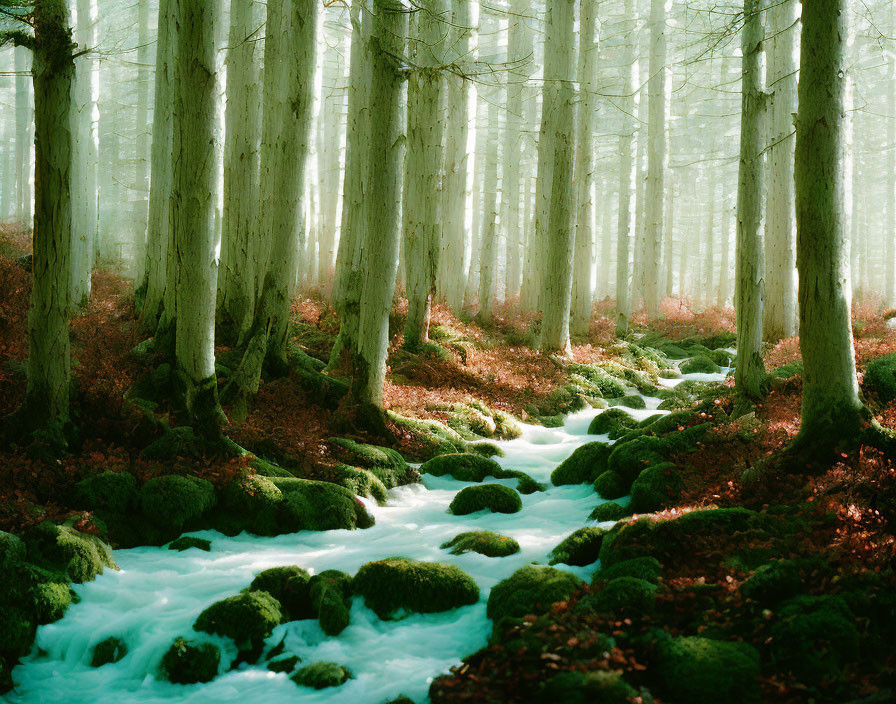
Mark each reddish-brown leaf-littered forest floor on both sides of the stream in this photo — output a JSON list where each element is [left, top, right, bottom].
[[0, 229, 896, 703]]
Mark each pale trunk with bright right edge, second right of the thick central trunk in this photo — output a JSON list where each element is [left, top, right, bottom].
[[438, 0, 472, 313]]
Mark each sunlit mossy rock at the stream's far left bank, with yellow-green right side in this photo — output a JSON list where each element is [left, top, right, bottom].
[[24, 521, 117, 584]]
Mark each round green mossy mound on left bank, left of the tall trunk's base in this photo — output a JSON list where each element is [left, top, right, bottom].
[[140, 474, 217, 533]]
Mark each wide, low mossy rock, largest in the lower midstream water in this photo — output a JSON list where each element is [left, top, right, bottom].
[[351, 557, 479, 620]]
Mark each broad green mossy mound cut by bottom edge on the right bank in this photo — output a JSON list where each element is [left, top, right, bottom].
[[656, 637, 760, 704]]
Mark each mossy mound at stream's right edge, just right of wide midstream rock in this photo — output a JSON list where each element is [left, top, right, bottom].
[[486, 565, 585, 623]]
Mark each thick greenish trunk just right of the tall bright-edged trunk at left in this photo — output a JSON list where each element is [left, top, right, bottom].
[[220, 0, 264, 341]]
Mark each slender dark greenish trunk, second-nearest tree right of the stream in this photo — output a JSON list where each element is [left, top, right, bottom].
[[734, 0, 765, 402]]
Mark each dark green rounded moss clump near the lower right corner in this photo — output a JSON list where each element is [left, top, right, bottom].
[[771, 596, 860, 684]]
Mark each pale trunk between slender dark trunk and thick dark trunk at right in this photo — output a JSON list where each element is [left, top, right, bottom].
[[763, 0, 800, 342]]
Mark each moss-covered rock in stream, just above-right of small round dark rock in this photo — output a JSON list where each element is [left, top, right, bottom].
[[193, 591, 283, 658]]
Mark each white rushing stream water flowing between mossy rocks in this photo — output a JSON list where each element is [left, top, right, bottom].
[[6, 366, 724, 704]]
